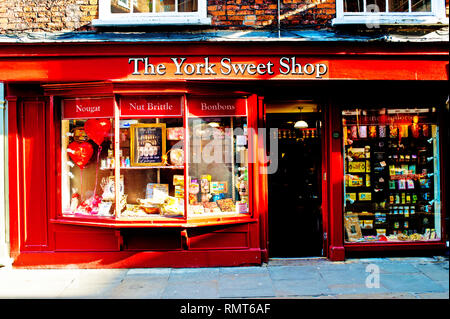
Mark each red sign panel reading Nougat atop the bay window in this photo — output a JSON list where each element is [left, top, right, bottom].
[[62, 97, 114, 120]]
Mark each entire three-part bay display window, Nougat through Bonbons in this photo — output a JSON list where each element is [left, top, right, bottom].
[[61, 95, 250, 222]]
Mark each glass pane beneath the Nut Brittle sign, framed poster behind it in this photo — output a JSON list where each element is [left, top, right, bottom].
[[120, 117, 184, 218]]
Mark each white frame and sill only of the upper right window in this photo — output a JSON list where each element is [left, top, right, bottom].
[[332, 0, 448, 27]]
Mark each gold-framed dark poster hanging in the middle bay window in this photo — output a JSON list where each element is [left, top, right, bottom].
[[130, 123, 166, 166]]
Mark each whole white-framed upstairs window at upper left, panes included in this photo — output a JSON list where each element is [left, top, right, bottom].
[[92, 0, 211, 27]]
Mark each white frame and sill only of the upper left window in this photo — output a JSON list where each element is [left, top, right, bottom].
[[92, 0, 211, 27]]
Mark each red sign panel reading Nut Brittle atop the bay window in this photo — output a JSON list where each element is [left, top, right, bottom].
[[120, 95, 183, 118]]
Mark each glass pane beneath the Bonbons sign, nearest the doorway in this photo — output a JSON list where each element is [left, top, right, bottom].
[[188, 117, 248, 217]]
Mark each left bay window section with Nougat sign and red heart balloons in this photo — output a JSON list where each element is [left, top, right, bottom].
[[61, 97, 114, 217]]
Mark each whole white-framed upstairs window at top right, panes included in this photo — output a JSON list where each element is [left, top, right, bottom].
[[333, 0, 448, 25]]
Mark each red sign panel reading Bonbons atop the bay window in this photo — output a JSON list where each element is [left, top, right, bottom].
[[188, 96, 247, 117]]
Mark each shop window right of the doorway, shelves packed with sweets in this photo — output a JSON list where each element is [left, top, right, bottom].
[[342, 108, 441, 242]]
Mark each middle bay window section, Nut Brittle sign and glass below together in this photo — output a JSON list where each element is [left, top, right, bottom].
[[119, 96, 185, 219]]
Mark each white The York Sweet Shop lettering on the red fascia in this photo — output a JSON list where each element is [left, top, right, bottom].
[[128, 57, 328, 79]]
